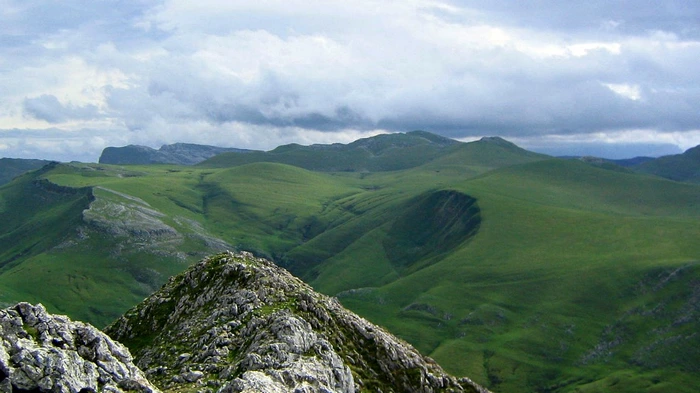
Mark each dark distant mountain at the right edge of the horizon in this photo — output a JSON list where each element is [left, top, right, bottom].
[[634, 145, 700, 183]]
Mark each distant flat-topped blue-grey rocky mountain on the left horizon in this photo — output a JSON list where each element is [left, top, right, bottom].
[[99, 143, 249, 165]]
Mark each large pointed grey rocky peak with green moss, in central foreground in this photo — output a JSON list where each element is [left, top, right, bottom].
[[107, 253, 486, 393]]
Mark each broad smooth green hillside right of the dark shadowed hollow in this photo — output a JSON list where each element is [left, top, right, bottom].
[[330, 160, 700, 392]]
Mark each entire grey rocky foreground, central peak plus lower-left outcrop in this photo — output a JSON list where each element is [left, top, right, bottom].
[[0, 253, 487, 393]]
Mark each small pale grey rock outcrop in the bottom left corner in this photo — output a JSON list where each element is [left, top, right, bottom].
[[0, 303, 158, 393]]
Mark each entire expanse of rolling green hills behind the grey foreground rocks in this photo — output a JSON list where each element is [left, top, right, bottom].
[[0, 133, 700, 392]]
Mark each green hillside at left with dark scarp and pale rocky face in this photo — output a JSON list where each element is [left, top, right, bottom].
[[0, 164, 227, 326]]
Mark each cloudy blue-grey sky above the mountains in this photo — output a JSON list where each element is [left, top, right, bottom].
[[0, 0, 700, 162]]
